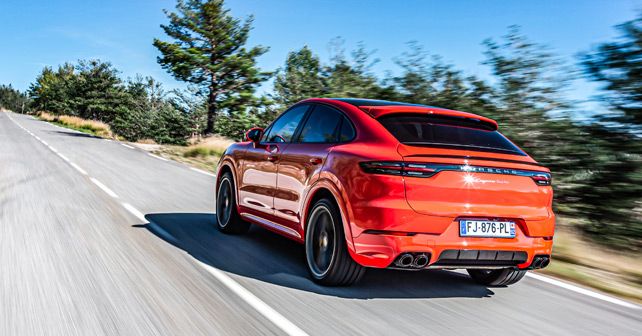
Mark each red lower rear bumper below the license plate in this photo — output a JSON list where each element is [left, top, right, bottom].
[[351, 221, 553, 269]]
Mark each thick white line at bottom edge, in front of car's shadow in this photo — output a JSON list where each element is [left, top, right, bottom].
[[193, 259, 308, 336]]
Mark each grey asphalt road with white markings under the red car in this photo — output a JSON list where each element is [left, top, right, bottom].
[[0, 113, 642, 335]]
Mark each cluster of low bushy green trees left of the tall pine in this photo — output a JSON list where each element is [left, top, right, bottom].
[[29, 60, 193, 144]]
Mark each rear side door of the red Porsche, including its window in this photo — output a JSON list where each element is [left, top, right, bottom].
[[274, 104, 348, 228]]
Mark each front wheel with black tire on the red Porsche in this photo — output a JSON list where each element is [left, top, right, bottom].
[[216, 172, 250, 234]]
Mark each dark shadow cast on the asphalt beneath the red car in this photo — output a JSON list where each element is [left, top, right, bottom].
[[137, 213, 494, 299]]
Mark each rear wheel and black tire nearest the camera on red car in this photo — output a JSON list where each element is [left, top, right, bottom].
[[305, 199, 366, 286]]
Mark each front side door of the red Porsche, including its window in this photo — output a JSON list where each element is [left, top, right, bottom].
[[238, 105, 309, 215]]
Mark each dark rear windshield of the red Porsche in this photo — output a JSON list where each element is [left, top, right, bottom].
[[379, 114, 526, 155]]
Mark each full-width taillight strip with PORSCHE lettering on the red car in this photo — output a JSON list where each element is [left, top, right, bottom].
[[359, 161, 551, 186]]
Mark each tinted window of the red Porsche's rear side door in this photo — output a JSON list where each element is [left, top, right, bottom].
[[299, 105, 343, 143]]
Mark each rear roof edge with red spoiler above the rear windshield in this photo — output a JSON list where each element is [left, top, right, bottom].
[[318, 98, 497, 129]]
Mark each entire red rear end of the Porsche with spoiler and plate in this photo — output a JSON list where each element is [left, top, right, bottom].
[[342, 106, 555, 269]]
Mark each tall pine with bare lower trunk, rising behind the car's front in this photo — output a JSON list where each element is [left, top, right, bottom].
[[154, 0, 269, 133]]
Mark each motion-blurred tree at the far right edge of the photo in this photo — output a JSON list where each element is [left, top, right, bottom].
[[580, 15, 642, 249]]
